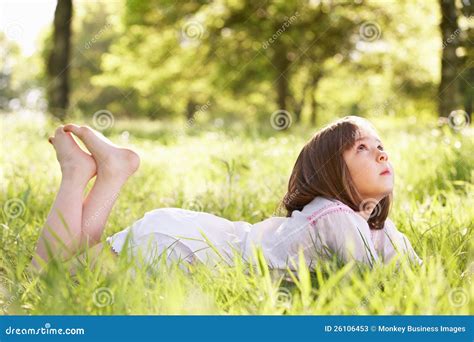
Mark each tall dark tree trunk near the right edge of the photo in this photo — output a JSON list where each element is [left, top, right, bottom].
[[438, 0, 460, 117]]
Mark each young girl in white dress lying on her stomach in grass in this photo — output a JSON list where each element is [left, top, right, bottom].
[[32, 116, 422, 269]]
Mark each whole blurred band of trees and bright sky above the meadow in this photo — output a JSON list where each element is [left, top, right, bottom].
[[0, 0, 474, 129]]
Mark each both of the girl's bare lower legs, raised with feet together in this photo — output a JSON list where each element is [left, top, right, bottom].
[[31, 124, 140, 269]]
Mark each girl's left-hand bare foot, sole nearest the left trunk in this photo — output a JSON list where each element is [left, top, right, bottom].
[[48, 126, 97, 184]]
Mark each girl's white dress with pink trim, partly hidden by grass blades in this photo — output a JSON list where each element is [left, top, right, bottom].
[[106, 197, 422, 269]]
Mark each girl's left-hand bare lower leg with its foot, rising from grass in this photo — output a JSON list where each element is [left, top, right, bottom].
[[32, 126, 96, 268]]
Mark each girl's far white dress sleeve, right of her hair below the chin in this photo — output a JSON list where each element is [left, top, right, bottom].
[[382, 218, 423, 265]]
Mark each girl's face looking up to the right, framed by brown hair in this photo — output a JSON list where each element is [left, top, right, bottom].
[[343, 128, 394, 201]]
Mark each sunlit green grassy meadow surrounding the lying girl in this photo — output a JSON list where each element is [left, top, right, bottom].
[[0, 115, 474, 315]]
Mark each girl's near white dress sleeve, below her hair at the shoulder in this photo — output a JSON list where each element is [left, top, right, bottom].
[[311, 208, 379, 266]]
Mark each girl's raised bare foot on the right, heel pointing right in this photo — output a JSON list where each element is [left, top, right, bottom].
[[64, 124, 140, 181]]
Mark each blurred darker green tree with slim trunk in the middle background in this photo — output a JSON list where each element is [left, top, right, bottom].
[[206, 1, 361, 122]]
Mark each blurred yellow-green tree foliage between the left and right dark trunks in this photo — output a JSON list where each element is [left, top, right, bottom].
[[78, 0, 439, 122]]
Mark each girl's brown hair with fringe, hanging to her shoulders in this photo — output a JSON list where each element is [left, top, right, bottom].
[[280, 116, 392, 229]]
